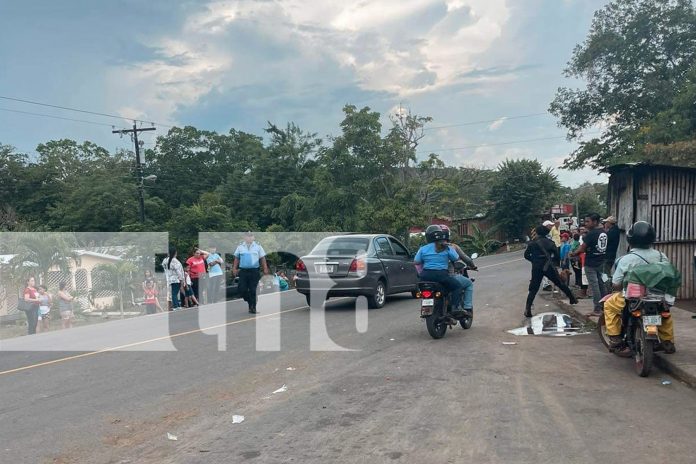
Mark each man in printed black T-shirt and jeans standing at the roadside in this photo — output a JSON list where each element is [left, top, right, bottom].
[[571, 213, 609, 315]]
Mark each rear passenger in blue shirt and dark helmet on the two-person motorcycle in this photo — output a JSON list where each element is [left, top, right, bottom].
[[413, 224, 471, 317]]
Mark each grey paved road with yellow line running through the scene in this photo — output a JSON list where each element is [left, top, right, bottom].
[[0, 253, 696, 463]]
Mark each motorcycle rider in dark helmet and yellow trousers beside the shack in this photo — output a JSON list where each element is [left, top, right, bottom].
[[604, 221, 676, 354]]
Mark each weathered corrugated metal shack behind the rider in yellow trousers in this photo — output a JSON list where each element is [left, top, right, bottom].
[[608, 163, 696, 299]]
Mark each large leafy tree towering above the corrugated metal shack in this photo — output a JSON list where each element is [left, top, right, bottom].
[[550, 0, 696, 169]]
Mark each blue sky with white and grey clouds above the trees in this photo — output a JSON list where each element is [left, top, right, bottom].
[[0, 0, 606, 186]]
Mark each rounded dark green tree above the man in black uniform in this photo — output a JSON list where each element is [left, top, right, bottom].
[[489, 159, 560, 238]]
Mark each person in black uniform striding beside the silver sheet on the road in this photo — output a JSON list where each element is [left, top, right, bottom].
[[524, 226, 578, 317]]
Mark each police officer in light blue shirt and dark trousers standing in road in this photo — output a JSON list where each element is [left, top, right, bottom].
[[232, 232, 270, 314]]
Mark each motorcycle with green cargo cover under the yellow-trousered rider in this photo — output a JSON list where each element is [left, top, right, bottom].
[[597, 283, 674, 377]]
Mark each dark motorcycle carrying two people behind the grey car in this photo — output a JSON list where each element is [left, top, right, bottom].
[[416, 253, 478, 340]]
